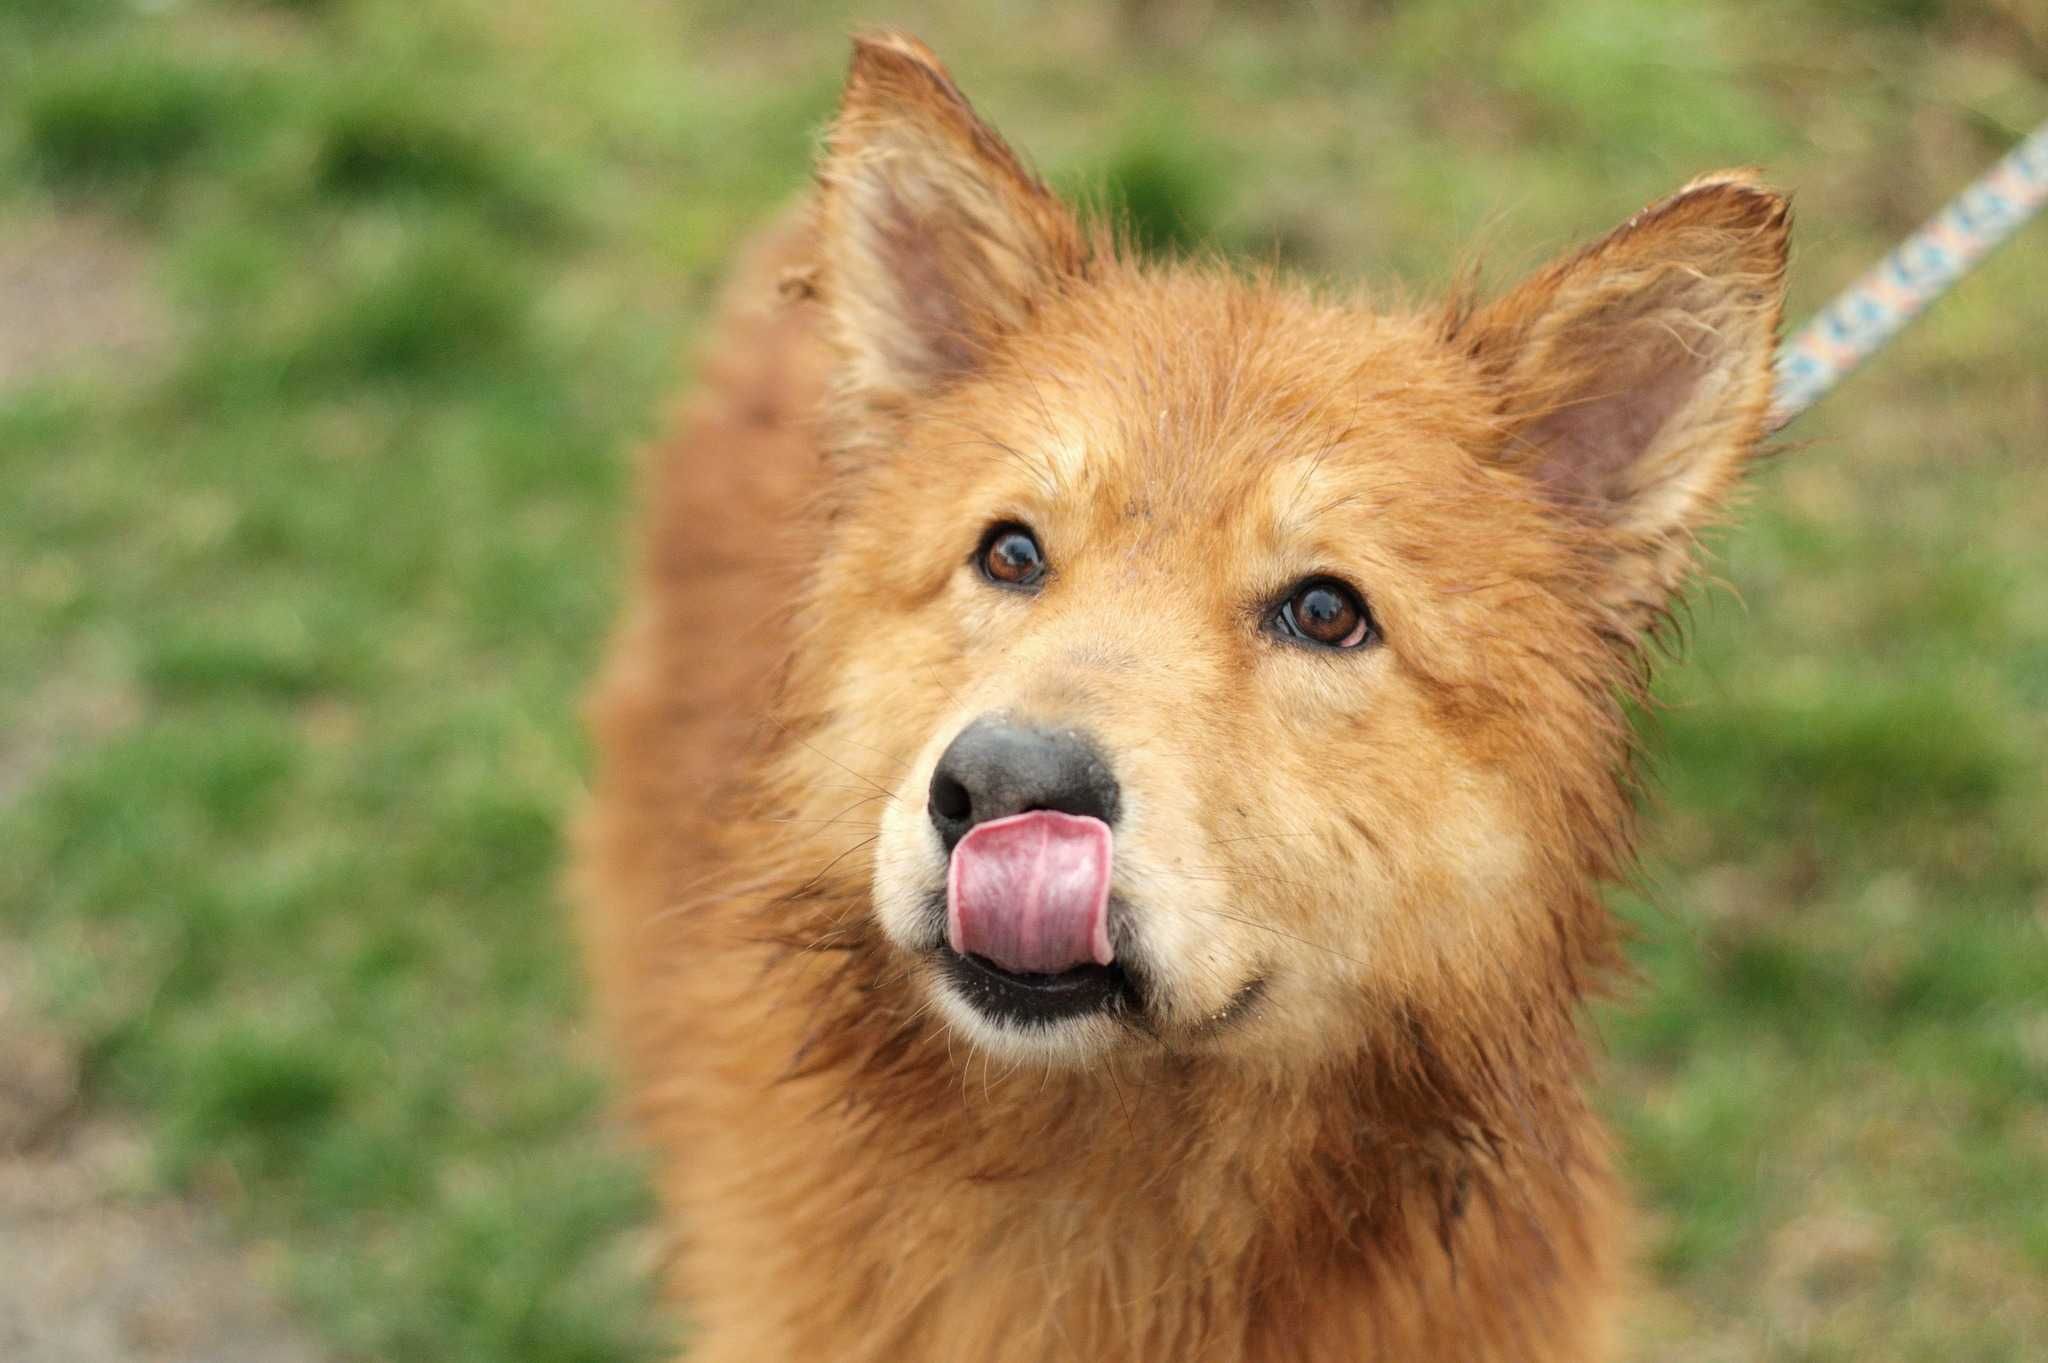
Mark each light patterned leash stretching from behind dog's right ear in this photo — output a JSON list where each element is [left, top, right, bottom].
[[1772, 123, 2048, 430]]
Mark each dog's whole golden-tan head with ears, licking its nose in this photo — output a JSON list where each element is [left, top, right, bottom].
[[797, 37, 1788, 1058]]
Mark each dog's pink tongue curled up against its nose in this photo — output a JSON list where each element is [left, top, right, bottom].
[[946, 808, 1116, 974]]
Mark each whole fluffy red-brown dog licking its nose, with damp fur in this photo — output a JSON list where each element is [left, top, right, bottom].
[[580, 35, 1788, 1363]]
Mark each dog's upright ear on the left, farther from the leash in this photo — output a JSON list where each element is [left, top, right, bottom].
[[817, 33, 1087, 409]]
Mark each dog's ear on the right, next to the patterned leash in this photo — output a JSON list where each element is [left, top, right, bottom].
[[1454, 172, 1790, 628]]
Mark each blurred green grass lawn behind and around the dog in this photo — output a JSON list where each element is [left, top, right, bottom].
[[0, 0, 2048, 1363]]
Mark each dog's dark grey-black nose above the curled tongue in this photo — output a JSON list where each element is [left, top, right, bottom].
[[926, 714, 1116, 853]]
